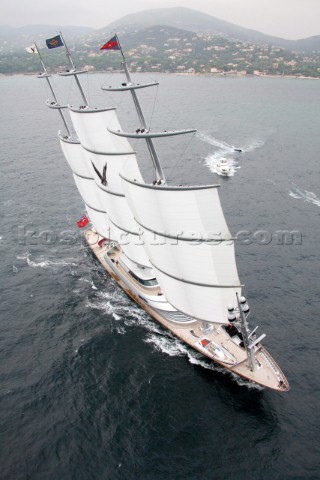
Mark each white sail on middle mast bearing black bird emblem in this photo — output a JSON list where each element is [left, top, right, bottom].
[[70, 109, 151, 267]]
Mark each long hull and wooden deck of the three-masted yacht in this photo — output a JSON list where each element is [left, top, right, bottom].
[[85, 228, 290, 392]]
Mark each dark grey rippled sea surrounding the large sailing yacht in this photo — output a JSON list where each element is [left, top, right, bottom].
[[0, 74, 320, 480]]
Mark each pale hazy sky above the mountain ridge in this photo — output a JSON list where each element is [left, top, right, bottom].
[[0, 0, 320, 39]]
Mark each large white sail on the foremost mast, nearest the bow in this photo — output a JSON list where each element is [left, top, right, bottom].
[[124, 178, 241, 323]]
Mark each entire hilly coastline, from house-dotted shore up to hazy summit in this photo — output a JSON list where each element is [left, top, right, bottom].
[[0, 8, 320, 78]]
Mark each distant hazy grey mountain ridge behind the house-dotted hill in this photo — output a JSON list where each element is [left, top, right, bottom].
[[0, 7, 320, 53]]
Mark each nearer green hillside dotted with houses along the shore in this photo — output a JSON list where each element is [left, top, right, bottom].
[[0, 26, 320, 78]]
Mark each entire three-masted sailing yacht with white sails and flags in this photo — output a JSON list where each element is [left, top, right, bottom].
[[29, 34, 289, 391]]
